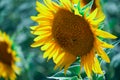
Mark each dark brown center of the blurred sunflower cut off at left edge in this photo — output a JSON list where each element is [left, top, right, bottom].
[[0, 41, 13, 66]]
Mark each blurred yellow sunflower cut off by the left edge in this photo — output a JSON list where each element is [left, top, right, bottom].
[[0, 31, 20, 80]]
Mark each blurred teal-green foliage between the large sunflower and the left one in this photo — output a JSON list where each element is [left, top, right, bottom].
[[0, 0, 54, 80]]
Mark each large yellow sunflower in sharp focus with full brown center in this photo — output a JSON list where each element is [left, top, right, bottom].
[[31, 0, 116, 77]]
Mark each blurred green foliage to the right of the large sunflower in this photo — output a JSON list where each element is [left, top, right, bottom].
[[101, 0, 120, 80]]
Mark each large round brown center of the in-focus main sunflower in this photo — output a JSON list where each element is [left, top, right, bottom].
[[52, 9, 94, 56]]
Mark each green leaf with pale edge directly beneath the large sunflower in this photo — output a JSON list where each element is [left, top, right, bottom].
[[48, 65, 80, 80]]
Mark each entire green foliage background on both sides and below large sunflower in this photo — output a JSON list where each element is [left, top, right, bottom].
[[0, 0, 120, 80]]
